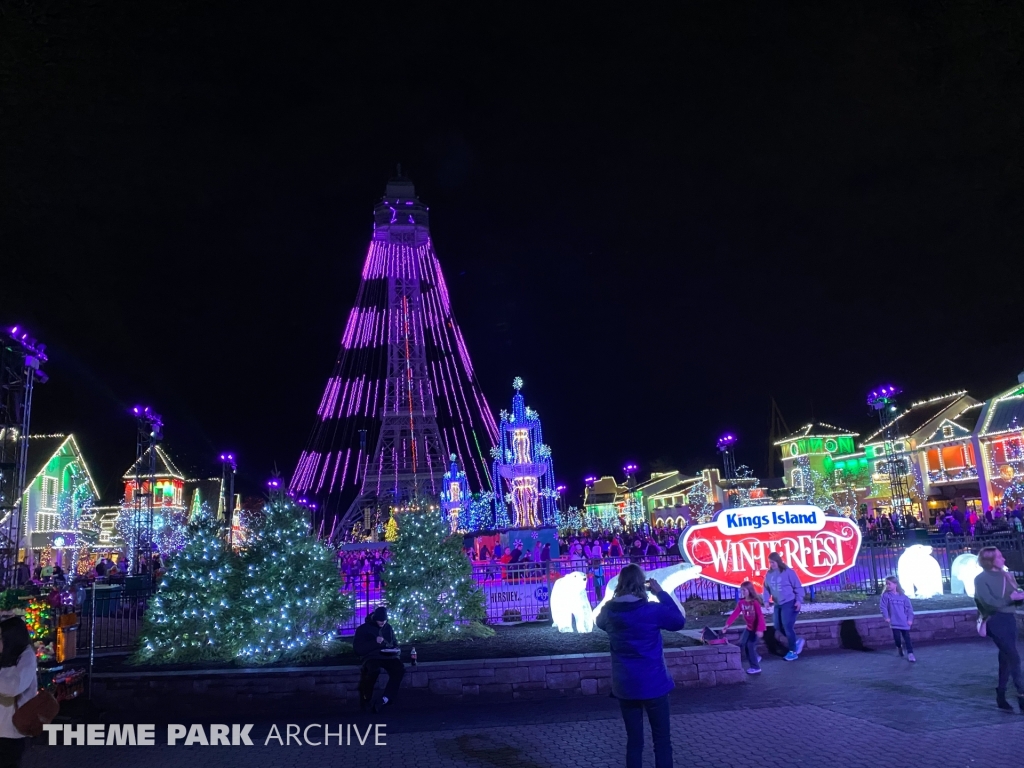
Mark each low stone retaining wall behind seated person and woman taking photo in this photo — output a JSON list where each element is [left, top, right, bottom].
[[93, 645, 744, 709]]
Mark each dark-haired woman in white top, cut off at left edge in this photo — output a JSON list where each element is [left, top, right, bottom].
[[0, 616, 38, 768]]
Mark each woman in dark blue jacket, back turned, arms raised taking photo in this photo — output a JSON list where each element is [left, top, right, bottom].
[[597, 563, 686, 768]]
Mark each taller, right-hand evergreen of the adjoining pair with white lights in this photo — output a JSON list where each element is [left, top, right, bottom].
[[237, 497, 352, 664]]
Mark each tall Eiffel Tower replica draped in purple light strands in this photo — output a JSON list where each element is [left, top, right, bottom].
[[290, 171, 498, 538]]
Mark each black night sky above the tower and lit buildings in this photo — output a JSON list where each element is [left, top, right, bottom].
[[0, 0, 1024, 502]]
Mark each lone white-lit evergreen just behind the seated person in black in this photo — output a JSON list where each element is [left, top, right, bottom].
[[384, 502, 489, 640]]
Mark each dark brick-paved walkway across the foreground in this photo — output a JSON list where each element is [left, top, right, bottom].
[[24, 640, 1024, 768]]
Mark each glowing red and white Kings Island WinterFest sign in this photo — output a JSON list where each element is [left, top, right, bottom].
[[683, 505, 860, 587]]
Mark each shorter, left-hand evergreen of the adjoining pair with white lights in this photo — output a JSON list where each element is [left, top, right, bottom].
[[135, 520, 239, 664]]
